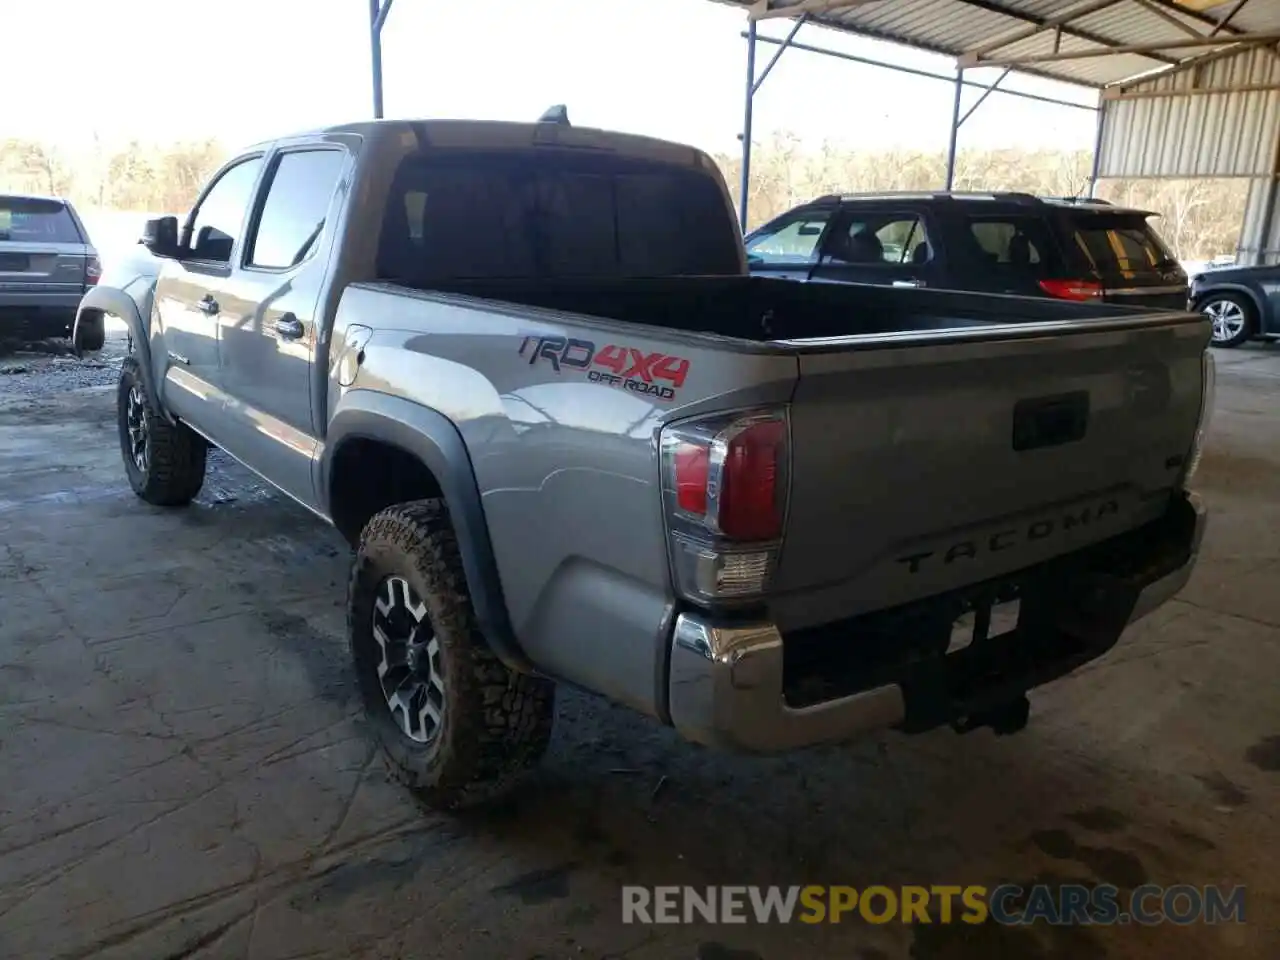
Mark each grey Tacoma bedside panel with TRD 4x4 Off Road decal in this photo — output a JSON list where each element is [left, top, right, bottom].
[[330, 284, 797, 717]]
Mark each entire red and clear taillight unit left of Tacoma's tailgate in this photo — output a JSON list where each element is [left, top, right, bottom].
[[662, 410, 791, 603]]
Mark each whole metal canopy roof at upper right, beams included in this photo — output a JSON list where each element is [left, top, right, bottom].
[[719, 0, 1280, 87]]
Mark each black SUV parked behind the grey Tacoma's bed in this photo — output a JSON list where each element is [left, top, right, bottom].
[[746, 193, 1187, 310]]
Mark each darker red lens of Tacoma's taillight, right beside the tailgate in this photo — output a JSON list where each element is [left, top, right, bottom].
[[717, 420, 787, 540]]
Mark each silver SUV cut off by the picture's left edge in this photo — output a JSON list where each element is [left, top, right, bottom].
[[0, 195, 104, 349]]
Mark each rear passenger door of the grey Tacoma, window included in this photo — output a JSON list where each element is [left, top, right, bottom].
[[218, 145, 348, 506]]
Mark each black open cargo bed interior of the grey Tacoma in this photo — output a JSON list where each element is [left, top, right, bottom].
[[435, 276, 1162, 342]]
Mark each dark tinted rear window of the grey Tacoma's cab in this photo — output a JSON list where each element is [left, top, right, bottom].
[[378, 147, 741, 287]]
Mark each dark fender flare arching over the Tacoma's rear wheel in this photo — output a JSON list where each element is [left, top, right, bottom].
[[325, 390, 536, 673]]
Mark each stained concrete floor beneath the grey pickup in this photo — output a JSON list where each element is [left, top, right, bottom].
[[0, 332, 1280, 960]]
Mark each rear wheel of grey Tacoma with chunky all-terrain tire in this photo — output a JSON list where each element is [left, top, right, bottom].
[[347, 500, 556, 809]]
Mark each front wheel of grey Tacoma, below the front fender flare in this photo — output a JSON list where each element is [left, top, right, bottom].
[[115, 357, 209, 507]]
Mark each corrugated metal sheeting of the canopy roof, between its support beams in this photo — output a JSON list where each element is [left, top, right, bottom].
[[721, 0, 1280, 87]]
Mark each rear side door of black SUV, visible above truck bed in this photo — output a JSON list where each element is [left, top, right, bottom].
[[810, 206, 940, 287]]
